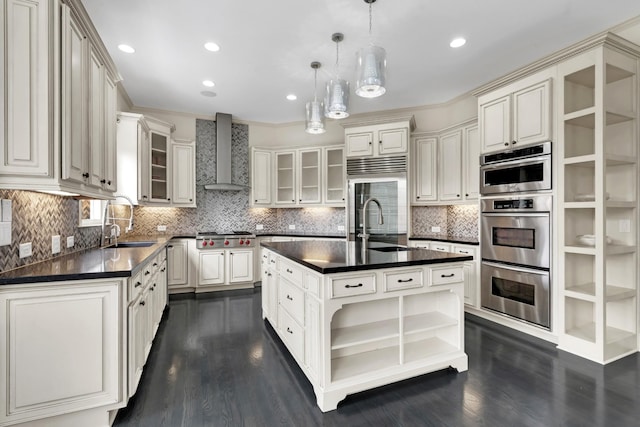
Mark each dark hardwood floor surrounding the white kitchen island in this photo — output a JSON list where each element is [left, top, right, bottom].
[[114, 288, 640, 427]]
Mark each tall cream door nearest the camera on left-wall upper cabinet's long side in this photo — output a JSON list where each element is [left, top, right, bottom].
[[61, 6, 89, 182]]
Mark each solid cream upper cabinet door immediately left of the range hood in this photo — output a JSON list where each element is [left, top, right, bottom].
[[171, 144, 196, 205]]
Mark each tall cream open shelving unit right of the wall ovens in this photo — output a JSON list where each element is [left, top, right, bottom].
[[557, 40, 638, 364]]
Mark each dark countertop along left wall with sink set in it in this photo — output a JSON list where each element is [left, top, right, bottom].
[[0, 236, 171, 286]]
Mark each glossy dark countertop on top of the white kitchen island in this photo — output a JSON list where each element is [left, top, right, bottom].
[[261, 241, 473, 274]]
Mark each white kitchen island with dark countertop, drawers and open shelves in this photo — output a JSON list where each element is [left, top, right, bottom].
[[261, 241, 472, 412]]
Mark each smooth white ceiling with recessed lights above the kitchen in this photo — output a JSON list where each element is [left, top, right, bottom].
[[83, 0, 640, 123]]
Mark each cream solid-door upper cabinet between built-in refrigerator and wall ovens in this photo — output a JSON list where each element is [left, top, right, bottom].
[[412, 120, 480, 205]]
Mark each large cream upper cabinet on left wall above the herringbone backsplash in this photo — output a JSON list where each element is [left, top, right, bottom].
[[0, 0, 118, 198]]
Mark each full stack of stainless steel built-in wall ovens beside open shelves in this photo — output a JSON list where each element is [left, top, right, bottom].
[[480, 142, 553, 329]]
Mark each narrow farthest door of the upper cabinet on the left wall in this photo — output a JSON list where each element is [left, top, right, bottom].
[[102, 72, 118, 192]]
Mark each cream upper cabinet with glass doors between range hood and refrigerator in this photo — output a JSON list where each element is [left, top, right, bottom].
[[251, 146, 345, 207]]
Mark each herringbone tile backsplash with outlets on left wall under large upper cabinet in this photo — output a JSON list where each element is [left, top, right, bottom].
[[0, 190, 100, 271]]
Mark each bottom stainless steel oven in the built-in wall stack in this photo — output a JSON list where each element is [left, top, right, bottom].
[[480, 261, 551, 329]]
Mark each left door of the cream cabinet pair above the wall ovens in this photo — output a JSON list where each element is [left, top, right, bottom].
[[480, 95, 511, 153]]
